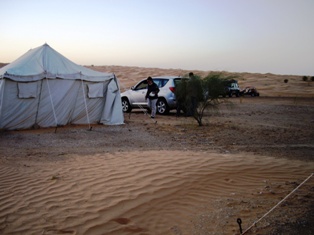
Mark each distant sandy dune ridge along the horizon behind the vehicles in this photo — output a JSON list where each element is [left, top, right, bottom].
[[87, 66, 314, 97]]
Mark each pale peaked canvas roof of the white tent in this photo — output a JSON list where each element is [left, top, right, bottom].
[[0, 43, 114, 82]]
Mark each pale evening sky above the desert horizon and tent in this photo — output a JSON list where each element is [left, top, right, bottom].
[[0, 0, 314, 76]]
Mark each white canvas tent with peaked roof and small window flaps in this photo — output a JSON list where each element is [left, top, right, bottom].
[[0, 44, 124, 130]]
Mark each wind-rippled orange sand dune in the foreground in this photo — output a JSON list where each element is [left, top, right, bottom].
[[0, 151, 314, 234]]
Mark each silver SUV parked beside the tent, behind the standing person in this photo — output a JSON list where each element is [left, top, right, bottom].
[[121, 76, 181, 114]]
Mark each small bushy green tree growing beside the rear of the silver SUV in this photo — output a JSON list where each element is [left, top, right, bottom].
[[176, 73, 235, 126]]
